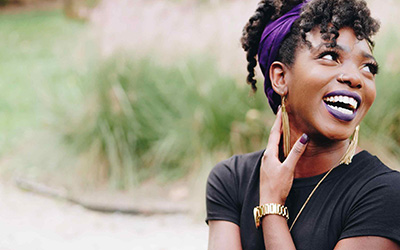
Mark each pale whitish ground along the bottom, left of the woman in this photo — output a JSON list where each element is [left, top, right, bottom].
[[0, 185, 208, 250]]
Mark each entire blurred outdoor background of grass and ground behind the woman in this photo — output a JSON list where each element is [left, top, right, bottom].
[[0, 0, 400, 249]]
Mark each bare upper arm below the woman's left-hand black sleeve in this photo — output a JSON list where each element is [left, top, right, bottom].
[[208, 220, 242, 250]]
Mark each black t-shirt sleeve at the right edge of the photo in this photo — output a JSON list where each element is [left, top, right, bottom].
[[340, 171, 400, 244]]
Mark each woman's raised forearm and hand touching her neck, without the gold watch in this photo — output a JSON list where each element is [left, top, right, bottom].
[[260, 110, 308, 250]]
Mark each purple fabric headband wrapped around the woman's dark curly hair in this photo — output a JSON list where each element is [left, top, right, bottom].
[[258, 1, 308, 113]]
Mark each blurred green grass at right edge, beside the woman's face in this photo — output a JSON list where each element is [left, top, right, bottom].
[[361, 26, 400, 157]]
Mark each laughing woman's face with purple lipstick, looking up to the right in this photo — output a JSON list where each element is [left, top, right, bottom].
[[285, 28, 377, 140]]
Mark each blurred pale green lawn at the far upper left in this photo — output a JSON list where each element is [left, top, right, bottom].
[[0, 11, 85, 155]]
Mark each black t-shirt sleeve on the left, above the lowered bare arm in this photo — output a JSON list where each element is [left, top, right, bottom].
[[206, 158, 240, 225]]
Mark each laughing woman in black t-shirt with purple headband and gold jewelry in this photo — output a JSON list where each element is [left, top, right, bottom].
[[206, 0, 400, 250]]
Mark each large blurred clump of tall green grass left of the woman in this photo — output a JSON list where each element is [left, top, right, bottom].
[[60, 54, 267, 187]]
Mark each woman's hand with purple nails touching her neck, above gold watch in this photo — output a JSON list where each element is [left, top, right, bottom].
[[260, 109, 308, 205]]
